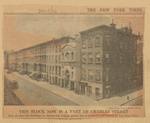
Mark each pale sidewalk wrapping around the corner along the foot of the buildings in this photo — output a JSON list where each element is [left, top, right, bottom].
[[10, 72, 143, 106]]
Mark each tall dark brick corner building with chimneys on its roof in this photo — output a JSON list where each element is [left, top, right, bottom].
[[80, 20, 138, 99]]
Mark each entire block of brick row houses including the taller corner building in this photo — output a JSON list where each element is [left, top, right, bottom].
[[8, 22, 142, 100]]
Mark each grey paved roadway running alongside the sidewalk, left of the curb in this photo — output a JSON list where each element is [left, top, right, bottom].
[[4, 72, 77, 105]]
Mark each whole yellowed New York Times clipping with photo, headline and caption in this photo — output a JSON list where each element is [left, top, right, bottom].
[[2, 4, 145, 119]]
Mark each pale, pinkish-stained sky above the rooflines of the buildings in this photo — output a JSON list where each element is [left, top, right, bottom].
[[2, 14, 144, 51]]
